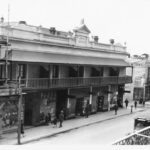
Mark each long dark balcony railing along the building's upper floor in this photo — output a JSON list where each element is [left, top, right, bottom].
[[14, 76, 132, 89]]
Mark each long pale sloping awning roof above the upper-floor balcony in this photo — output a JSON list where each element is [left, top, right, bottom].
[[9, 50, 130, 66]]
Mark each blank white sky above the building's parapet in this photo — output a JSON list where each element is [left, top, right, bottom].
[[0, 0, 150, 55]]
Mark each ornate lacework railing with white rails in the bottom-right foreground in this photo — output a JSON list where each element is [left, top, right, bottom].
[[113, 126, 150, 145]]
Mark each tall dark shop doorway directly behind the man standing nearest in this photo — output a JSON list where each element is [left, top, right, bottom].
[[56, 90, 67, 118]]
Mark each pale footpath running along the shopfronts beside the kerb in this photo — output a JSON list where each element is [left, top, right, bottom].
[[0, 103, 150, 145]]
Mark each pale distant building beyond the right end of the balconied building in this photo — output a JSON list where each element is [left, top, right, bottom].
[[125, 56, 150, 101]]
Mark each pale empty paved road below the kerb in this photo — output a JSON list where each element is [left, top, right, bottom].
[[30, 110, 150, 145]]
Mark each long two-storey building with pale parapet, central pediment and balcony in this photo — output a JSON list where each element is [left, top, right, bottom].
[[0, 21, 132, 125]]
